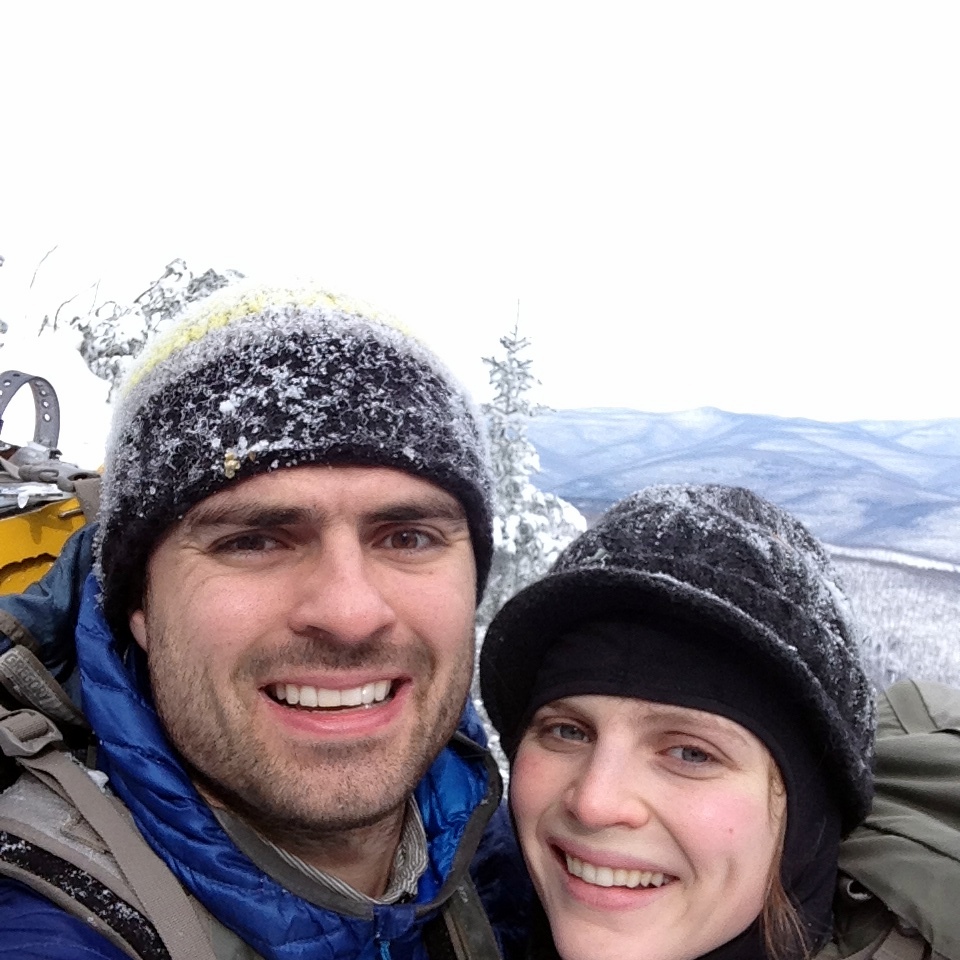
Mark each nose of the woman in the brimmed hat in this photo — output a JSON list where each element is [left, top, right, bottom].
[[563, 751, 652, 830]]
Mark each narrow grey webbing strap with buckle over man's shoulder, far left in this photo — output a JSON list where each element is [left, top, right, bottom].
[[0, 706, 214, 960]]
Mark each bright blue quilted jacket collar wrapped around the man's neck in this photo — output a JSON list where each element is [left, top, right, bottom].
[[77, 576, 500, 960]]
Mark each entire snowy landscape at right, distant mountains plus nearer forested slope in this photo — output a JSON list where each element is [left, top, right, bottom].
[[529, 409, 960, 685]]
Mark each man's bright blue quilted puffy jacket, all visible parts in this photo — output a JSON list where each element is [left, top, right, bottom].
[[0, 528, 528, 960]]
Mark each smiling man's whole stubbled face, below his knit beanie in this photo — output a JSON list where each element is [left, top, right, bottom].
[[130, 466, 476, 842]]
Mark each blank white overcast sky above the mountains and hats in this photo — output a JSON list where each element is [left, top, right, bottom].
[[0, 0, 960, 436]]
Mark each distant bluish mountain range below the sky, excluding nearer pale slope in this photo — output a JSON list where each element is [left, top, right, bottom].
[[529, 408, 960, 562]]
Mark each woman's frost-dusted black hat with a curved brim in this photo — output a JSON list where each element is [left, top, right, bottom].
[[480, 485, 875, 830]]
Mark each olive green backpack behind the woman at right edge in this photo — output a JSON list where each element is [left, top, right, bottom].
[[818, 680, 960, 960]]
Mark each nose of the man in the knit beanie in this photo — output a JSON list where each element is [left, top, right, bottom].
[[289, 533, 396, 642]]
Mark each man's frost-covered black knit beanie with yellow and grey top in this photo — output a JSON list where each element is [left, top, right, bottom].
[[97, 284, 492, 626]]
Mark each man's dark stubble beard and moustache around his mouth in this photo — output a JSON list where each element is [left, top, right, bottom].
[[147, 615, 473, 847]]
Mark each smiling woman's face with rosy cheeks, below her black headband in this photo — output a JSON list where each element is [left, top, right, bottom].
[[510, 696, 785, 960]]
